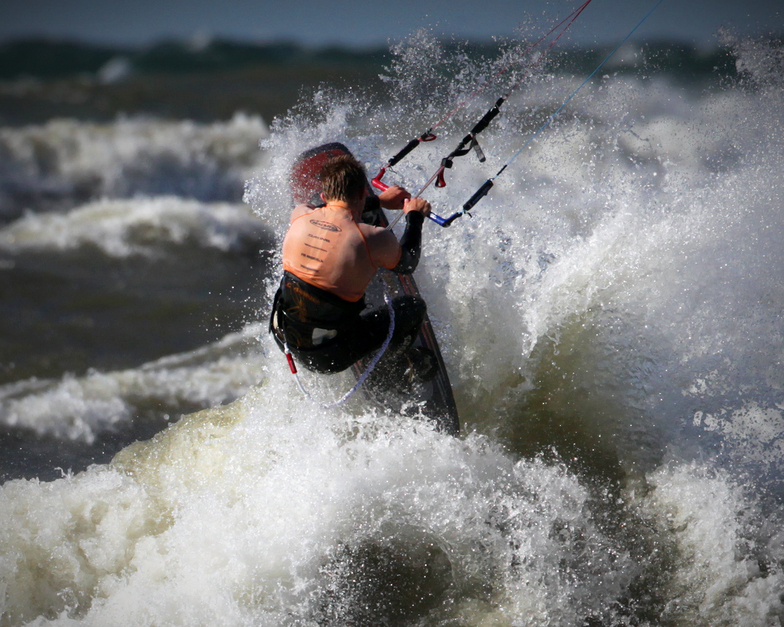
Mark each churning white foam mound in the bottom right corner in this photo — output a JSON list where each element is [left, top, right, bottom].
[[643, 463, 784, 626]]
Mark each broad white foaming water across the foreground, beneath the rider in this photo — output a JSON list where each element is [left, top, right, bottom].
[[0, 388, 784, 627]]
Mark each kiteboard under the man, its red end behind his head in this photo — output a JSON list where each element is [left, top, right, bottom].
[[291, 142, 460, 435]]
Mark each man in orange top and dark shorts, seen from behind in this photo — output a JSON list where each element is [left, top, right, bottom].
[[270, 155, 436, 376]]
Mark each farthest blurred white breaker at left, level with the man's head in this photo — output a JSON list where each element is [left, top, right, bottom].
[[0, 113, 269, 221]]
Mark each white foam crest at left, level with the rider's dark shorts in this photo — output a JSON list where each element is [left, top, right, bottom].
[[0, 325, 265, 444]]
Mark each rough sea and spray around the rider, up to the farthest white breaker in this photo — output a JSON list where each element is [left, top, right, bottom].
[[0, 33, 784, 627]]
